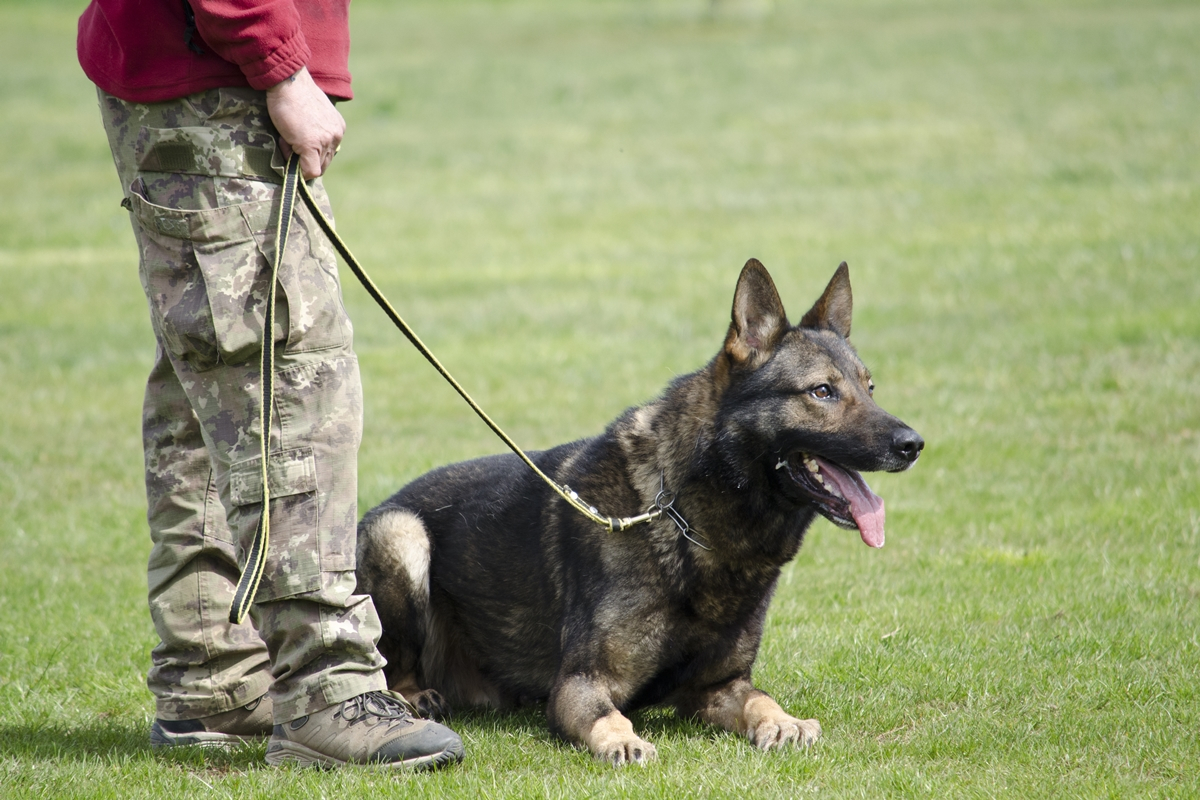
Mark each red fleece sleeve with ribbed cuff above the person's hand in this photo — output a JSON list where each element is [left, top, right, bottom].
[[191, 0, 312, 89]]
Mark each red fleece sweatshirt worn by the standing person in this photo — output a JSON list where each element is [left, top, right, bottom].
[[77, 0, 353, 103]]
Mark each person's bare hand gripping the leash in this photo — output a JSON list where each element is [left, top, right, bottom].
[[266, 68, 346, 180]]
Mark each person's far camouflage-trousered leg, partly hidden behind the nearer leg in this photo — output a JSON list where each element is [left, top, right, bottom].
[[100, 92, 272, 746]]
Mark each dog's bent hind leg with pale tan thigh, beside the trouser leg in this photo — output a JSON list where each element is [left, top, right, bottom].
[[356, 507, 450, 720]]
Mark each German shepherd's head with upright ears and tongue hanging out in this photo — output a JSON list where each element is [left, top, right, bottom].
[[722, 259, 925, 547]]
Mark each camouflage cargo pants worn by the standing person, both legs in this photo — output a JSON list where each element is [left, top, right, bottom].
[[100, 89, 384, 722]]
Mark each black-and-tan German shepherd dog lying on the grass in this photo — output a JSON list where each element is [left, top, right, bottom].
[[358, 259, 924, 765]]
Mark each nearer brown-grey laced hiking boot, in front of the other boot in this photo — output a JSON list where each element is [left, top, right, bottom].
[[266, 692, 462, 768]]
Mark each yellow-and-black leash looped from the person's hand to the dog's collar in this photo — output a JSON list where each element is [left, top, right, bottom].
[[229, 154, 672, 624]]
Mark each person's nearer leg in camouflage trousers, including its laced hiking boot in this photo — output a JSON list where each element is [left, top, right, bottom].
[[102, 90, 462, 766]]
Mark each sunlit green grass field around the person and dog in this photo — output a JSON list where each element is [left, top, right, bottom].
[[0, 0, 1200, 800]]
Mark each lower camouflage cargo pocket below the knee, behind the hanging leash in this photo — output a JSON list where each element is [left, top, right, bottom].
[[229, 447, 320, 601]]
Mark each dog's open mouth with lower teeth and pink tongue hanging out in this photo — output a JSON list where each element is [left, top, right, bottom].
[[775, 452, 884, 547]]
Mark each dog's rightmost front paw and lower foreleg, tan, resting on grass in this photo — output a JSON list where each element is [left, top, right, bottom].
[[676, 678, 821, 750]]
